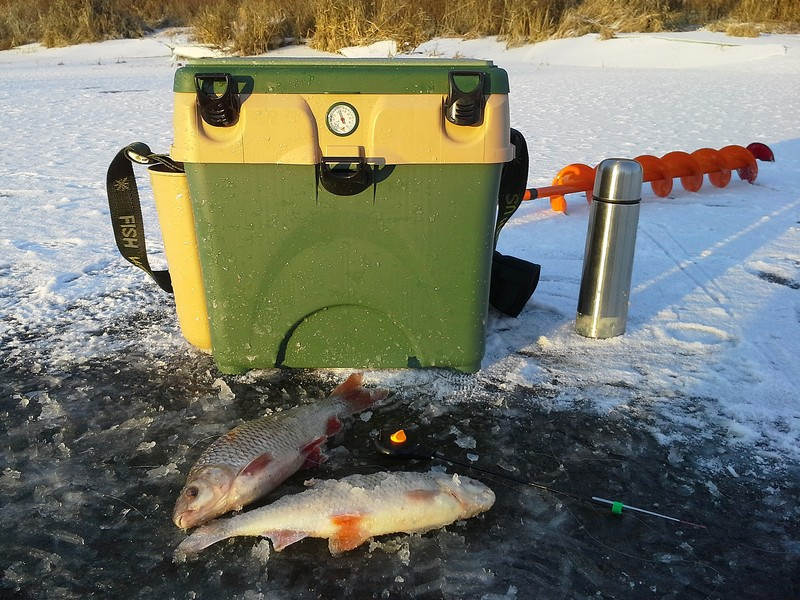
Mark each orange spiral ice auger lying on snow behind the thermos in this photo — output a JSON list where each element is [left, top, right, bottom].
[[523, 142, 775, 213]]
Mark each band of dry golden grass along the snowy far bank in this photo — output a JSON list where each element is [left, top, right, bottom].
[[0, 0, 800, 54]]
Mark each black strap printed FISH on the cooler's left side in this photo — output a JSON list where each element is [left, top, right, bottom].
[[106, 142, 183, 293]]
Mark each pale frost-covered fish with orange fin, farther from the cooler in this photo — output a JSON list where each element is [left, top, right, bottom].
[[177, 472, 494, 556]]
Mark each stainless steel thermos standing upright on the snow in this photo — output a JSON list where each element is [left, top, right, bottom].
[[575, 158, 642, 338]]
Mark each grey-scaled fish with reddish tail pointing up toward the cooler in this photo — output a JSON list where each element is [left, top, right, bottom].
[[172, 373, 389, 529]]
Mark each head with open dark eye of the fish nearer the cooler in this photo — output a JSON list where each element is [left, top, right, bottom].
[[172, 466, 237, 529]]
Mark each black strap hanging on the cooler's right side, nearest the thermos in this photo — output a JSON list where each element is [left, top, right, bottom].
[[489, 129, 541, 317]]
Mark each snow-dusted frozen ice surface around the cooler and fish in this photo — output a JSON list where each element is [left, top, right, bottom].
[[0, 31, 800, 600]]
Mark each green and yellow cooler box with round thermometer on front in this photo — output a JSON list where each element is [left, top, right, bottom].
[[170, 58, 513, 373]]
